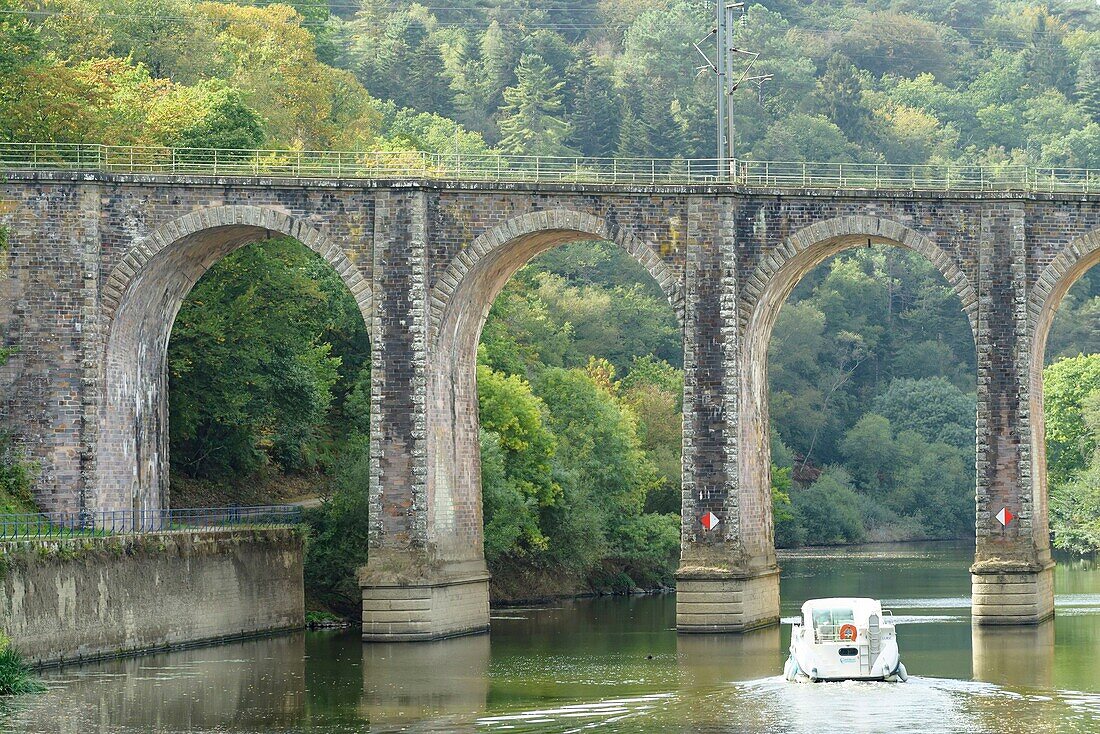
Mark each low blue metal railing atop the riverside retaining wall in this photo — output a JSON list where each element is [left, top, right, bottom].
[[0, 505, 301, 541]]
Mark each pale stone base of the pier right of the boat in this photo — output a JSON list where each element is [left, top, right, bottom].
[[970, 560, 1054, 625]]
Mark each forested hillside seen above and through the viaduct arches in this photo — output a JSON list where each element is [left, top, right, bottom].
[[0, 0, 1100, 606]]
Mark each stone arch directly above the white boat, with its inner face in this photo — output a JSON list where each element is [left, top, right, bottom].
[[730, 216, 978, 556]]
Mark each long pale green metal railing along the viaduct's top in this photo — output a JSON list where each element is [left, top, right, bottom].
[[0, 143, 1100, 194]]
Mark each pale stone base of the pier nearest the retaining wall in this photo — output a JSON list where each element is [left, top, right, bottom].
[[359, 552, 490, 643]]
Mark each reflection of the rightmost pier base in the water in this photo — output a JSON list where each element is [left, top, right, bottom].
[[970, 620, 1054, 689]]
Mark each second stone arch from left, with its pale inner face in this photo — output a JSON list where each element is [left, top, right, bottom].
[[426, 209, 684, 565]]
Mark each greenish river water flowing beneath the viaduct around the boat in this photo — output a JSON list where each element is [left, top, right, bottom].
[[0, 544, 1100, 734]]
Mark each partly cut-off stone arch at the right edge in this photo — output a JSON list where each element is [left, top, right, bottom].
[[1021, 230, 1100, 548]]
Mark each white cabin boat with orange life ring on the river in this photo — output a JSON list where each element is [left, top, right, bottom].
[[783, 599, 908, 682]]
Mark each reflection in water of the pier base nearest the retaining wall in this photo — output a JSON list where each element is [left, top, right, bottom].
[[360, 635, 490, 726]]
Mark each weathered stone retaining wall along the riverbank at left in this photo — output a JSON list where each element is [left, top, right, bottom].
[[0, 528, 305, 664]]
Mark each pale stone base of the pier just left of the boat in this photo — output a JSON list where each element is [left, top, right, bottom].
[[677, 568, 779, 633]]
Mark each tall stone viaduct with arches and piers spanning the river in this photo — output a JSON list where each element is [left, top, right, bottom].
[[0, 172, 1100, 639]]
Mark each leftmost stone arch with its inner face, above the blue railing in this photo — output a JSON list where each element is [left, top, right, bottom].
[[92, 206, 372, 511]]
